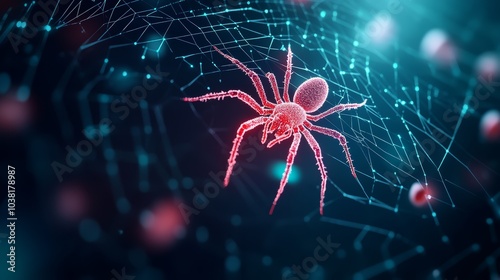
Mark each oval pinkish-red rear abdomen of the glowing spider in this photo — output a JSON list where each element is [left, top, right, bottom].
[[293, 78, 328, 113]]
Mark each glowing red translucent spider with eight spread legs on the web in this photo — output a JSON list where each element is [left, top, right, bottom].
[[183, 46, 366, 215]]
